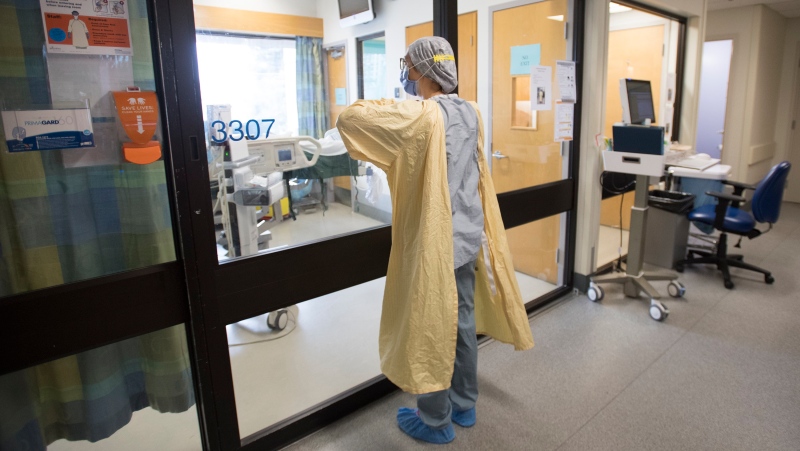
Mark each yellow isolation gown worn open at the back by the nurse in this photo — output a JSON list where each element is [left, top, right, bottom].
[[337, 99, 533, 394]]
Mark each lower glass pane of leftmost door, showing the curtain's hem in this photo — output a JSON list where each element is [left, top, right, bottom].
[[0, 325, 202, 451]]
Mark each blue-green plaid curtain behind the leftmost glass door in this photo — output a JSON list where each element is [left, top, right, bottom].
[[0, 0, 194, 451]]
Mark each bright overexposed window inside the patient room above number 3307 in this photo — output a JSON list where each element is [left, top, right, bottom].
[[197, 32, 299, 136]]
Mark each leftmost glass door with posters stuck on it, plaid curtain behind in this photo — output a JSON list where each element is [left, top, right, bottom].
[[0, 0, 202, 450]]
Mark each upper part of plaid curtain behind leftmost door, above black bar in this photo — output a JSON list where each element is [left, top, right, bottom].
[[0, 0, 175, 296]]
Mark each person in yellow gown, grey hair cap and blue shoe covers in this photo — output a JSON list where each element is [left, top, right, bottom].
[[337, 37, 533, 443]]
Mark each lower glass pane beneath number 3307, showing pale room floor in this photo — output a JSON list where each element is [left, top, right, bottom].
[[227, 278, 386, 438]]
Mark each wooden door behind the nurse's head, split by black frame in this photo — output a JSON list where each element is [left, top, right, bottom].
[[406, 11, 478, 102]]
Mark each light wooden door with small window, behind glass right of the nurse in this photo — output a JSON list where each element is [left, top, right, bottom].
[[491, 0, 568, 284]]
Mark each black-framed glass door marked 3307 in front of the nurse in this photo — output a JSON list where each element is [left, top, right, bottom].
[[162, 1, 433, 449]]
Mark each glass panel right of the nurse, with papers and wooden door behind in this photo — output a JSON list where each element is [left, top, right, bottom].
[[490, 0, 578, 305]]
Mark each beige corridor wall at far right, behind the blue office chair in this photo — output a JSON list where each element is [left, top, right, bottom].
[[706, 5, 789, 183]]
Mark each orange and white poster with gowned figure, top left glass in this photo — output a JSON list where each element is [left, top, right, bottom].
[[39, 0, 133, 55]]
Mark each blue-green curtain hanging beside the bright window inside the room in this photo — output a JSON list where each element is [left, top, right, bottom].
[[296, 36, 330, 139]]
